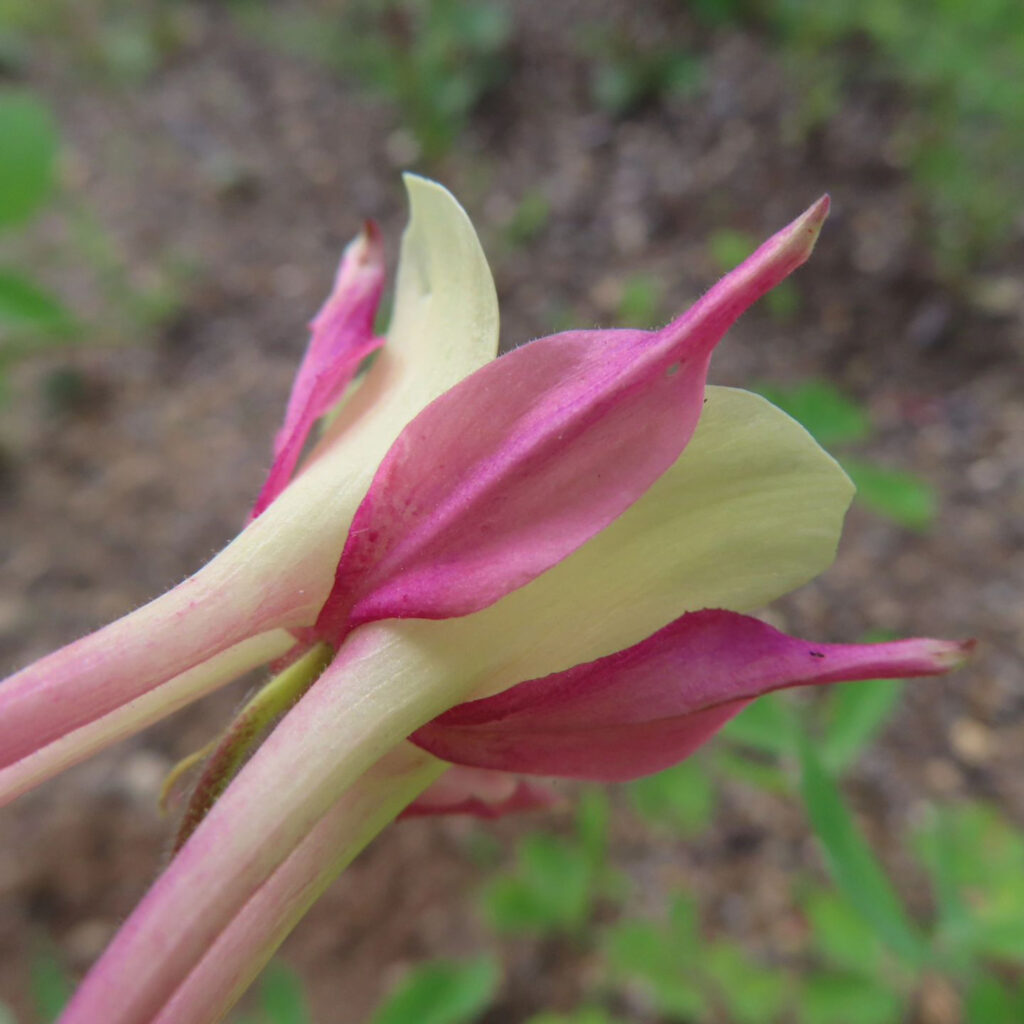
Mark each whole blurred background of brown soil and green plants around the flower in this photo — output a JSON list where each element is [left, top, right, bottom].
[[0, 0, 1024, 1024]]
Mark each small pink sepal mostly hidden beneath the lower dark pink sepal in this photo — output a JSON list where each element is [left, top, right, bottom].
[[398, 767, 561, 818]]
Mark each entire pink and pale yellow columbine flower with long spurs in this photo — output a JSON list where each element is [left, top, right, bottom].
[[0, 178, 966, 1024]]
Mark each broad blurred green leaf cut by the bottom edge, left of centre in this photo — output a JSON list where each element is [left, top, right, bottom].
[[372, 956, 499, 1024]]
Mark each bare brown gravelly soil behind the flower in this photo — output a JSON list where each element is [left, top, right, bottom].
[[0, 0, 1024, 1024]]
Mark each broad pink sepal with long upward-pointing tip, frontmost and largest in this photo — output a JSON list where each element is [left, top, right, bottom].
[[317, 198, 828, 642]]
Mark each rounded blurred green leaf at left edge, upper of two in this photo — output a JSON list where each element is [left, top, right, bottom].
[[0, 89, 58, 228]]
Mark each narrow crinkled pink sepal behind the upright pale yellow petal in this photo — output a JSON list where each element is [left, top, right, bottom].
[[250, 220, 385, 519]]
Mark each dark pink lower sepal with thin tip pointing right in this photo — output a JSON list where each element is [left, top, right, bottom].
[[411, 611, 972, 781]]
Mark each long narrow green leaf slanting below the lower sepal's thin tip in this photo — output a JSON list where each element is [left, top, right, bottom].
[[800, 736, 928, 967]]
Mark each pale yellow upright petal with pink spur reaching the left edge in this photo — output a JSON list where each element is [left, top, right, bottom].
[[0, 177, 498, 768]]
